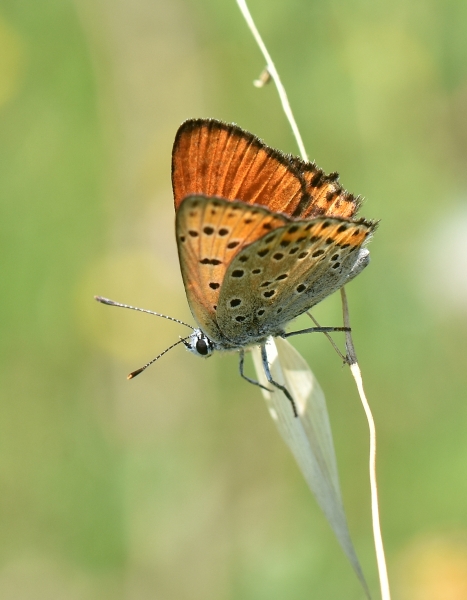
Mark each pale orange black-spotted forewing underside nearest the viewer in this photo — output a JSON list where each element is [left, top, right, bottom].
[[175, 195, 290, 342]]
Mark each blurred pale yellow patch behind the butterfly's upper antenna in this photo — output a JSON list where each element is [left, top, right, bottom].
[[77, 251, 194, 360]]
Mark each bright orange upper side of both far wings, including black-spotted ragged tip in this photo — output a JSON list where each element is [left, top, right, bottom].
[[172, 119, 361, 219]]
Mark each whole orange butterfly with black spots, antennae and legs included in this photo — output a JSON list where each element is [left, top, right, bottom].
[[96, 119, 377, 414]]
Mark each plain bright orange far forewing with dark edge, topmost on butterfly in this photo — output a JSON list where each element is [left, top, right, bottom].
[[172, 119, 306, 215]]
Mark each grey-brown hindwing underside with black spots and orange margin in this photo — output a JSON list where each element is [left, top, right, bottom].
[[217, 217, 376, 344]]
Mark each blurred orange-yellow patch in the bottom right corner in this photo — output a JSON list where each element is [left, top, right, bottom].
[[395, 535, 467, 600]]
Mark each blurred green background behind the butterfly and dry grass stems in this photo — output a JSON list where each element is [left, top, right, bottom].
[[0, 0, 467, 600]]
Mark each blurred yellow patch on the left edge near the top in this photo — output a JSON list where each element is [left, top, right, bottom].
[[0, 17, 24, 108]]
